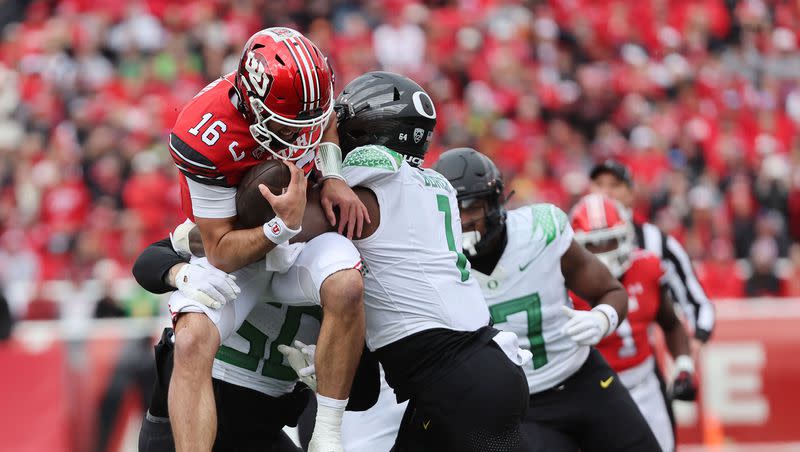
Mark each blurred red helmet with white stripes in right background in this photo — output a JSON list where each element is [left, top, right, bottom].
[[569, 193, 635, 278]]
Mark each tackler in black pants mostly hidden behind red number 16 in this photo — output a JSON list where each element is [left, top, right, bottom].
[[133, 225, 378, 452]]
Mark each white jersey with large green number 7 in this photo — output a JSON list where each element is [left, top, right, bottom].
[[472, 204, 589, 394]]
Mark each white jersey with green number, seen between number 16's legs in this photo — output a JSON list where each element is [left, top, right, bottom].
[[216, 303, 322, 397]]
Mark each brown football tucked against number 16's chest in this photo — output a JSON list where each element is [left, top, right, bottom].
[[236, 160, 292, 228]]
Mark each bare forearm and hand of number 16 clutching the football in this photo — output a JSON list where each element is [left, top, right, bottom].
[[195, 162, 306, 273]]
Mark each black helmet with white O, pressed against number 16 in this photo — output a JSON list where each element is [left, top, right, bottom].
[[334, 72, 436, 166]]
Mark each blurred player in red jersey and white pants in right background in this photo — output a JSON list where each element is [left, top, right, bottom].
[[570, 194, 697, 452]]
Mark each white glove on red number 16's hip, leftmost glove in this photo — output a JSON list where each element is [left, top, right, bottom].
[[175, 264, 242, 309]]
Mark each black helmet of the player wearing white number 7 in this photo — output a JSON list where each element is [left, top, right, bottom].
[[433, 148, 506, 255]]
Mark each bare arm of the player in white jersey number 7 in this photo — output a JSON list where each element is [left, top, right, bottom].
[[561, 240, 628, 322]]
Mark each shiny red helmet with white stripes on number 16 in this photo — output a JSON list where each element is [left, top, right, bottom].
[[236, 27, 333, 160]]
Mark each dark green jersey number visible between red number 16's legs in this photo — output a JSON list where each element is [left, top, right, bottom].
[[217, 303, 322, 381]]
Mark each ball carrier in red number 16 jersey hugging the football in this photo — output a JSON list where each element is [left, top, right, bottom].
[[169, 27, 366, 452]]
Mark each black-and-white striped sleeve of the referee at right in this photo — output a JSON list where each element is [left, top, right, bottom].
[[663, 236, 715, 342]]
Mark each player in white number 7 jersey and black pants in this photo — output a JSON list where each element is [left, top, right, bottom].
[[332, 148, 658, 452]]
